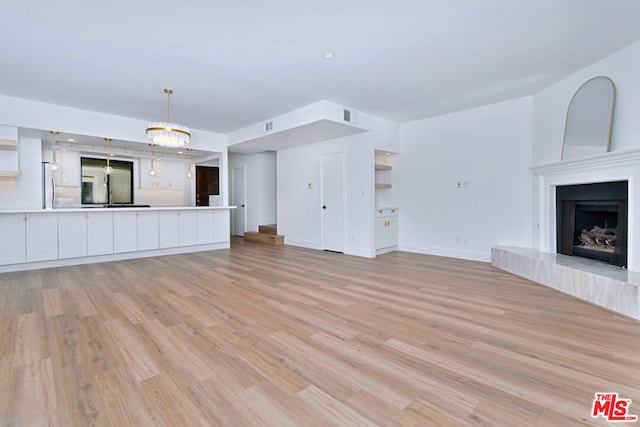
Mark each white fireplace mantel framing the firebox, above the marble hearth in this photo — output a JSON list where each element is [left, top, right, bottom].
[[531, 150, 640, 271]]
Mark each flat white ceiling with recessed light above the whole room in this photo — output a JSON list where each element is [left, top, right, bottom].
[[0, 0, 640, 133]]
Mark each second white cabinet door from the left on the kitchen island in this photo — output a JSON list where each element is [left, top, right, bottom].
[[25, 212, 58, 262]]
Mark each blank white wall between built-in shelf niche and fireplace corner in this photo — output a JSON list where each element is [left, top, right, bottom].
[[397, 97, 533, 261]]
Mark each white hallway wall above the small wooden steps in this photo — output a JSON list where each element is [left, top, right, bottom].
[[229, 152, 277, 231]]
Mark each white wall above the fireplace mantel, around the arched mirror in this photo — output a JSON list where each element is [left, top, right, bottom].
[[533, 42, 640, 165]]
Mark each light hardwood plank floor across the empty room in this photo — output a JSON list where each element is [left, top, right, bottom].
[[0, 239, 640, 427]]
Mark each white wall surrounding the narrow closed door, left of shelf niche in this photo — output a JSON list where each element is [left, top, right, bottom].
[[277, 112, 399, 257]]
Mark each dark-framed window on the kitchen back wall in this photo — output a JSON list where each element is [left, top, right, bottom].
[[80, 157, 133, 205]]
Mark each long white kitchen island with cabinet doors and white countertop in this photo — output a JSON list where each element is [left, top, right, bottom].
[[0, 206, 235, 273]]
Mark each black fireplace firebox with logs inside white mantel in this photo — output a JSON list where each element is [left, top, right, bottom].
[[556, 181, 628, 267]]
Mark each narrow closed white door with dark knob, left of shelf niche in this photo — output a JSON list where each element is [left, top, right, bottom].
[[321, 153, 345, 252]]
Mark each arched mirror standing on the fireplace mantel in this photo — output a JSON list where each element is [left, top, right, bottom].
[[562, 77, 616, 160]]
